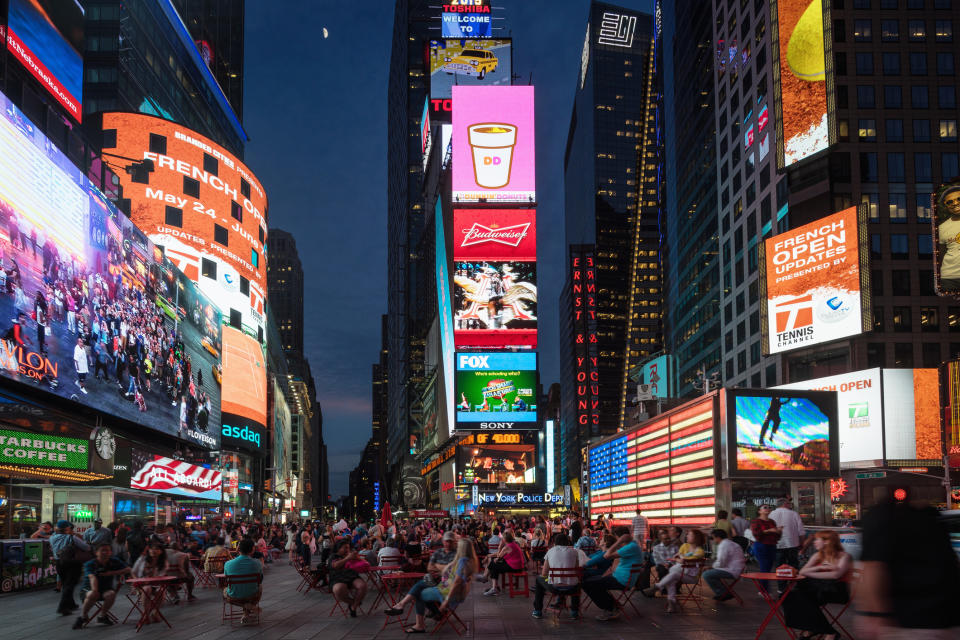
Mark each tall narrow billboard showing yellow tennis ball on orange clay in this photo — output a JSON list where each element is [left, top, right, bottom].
[[774, 0, 830, 169]]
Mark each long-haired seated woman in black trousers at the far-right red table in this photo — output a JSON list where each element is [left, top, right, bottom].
[[783, 531, 853, 640]]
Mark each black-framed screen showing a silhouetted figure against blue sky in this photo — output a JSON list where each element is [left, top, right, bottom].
[[726, 389, 840, 478]]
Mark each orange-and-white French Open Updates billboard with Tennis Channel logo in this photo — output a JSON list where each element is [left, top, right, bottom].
[[760, 207, 871, 354]]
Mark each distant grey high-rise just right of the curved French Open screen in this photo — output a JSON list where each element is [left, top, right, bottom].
[[267, 229, 303, 354]]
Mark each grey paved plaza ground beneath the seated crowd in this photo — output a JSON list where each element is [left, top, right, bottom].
[[0, 564, 804, 640]]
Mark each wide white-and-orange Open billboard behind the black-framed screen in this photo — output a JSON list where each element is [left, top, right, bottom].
[[777, 369, 942, 464]]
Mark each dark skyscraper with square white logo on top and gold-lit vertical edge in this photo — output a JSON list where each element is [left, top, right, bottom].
[[561, 2, 663, 446]]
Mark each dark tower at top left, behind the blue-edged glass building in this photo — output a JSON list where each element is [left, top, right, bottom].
[[173, 0, 245, 120]]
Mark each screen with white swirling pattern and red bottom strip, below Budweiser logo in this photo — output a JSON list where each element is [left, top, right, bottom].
[[453, 260, 537, 348]]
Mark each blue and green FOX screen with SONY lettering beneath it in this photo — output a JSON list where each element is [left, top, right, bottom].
[[456, 353, 538, 431]]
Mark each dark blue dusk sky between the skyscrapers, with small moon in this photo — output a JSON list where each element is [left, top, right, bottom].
[[243, 0, 653, 498]]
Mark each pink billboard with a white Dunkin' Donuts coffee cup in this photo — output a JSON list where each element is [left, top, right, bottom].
[[452, 86, 537, 204]]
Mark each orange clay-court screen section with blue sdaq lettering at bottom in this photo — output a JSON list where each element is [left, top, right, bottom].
[[220, 326, 269, 453]]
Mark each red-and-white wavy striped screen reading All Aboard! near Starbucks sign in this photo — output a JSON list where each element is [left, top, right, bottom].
[[130, 449, 223, 500]]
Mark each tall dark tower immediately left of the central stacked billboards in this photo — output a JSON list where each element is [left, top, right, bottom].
[[387, 0, 436, 505]]
